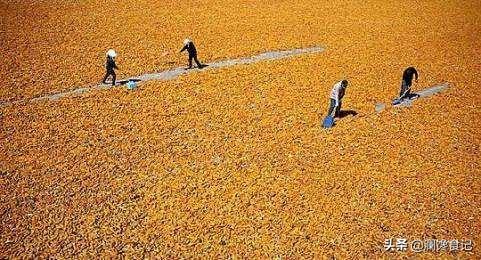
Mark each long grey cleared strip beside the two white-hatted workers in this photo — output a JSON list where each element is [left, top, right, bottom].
[[0, 47, 325, 107]]
